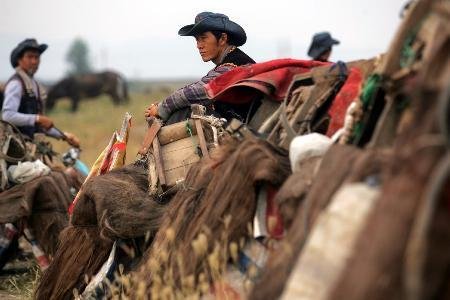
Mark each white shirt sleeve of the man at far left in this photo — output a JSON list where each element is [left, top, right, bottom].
[[2, 80, 36, 126]]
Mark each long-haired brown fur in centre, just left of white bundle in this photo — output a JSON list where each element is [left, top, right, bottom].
[[135, 138, 290, 290]]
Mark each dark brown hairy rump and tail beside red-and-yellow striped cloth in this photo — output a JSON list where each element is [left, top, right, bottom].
[[36, 166, 164, 299]]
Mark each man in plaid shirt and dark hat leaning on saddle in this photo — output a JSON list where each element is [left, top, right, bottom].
[[145, 12, 255, 124]]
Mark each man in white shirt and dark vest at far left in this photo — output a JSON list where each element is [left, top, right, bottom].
[[1, 39, 79, 146]]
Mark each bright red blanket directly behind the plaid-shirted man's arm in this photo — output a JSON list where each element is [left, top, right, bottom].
[[205, 58, 330, 104]]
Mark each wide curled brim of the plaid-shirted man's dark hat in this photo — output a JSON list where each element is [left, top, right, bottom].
[[178, 18, 247, 46]]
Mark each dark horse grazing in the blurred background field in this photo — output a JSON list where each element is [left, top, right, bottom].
[[46, 71, 129, 112]]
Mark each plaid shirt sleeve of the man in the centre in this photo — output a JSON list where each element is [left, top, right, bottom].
[[158, 65, 233, 120]]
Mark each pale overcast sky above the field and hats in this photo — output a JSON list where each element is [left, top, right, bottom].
[[0, 0, 405, 81]]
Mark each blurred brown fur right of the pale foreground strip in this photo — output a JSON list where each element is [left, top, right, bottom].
[[330, 86, 450, 299]]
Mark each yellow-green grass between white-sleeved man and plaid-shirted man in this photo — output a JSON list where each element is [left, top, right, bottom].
[[48, 90, 174, 167]]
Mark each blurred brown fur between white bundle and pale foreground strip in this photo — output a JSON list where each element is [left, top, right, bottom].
[[249, 145, 385, 299]]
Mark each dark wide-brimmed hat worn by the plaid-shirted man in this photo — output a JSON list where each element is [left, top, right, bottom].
[[178, 11, 247, 46]]
